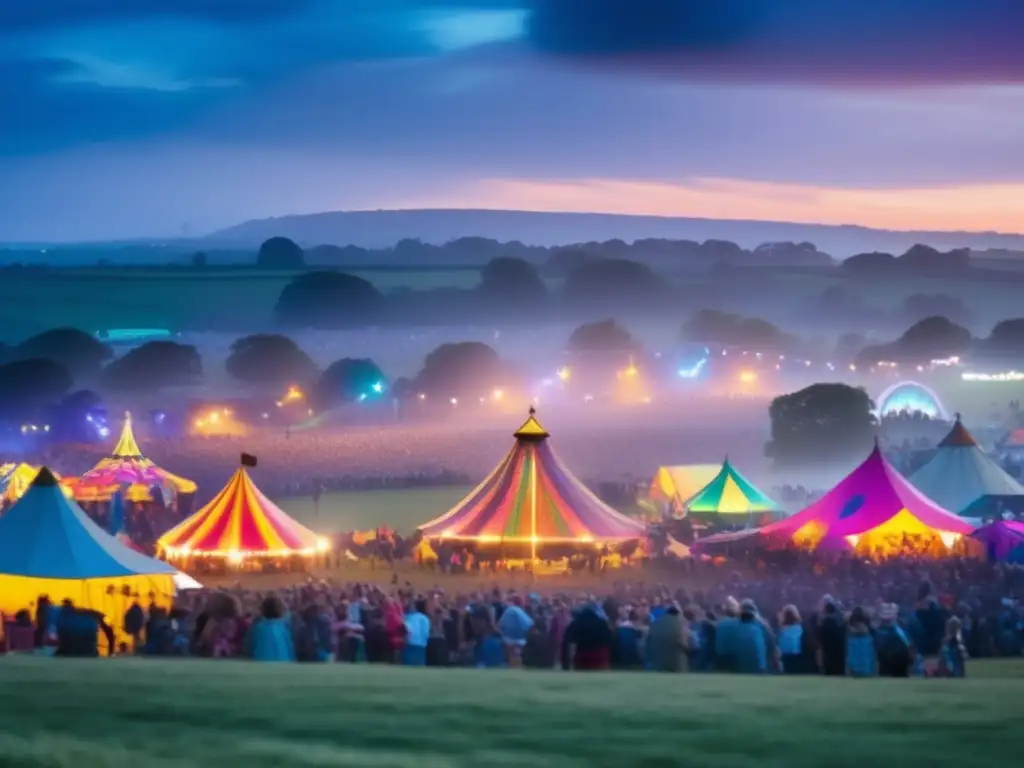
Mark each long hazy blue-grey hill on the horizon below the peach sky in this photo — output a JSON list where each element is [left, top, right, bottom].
[[203, 210, 1024, 258]]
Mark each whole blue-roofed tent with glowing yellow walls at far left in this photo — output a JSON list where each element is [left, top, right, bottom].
[[0, 467, 175, 627]]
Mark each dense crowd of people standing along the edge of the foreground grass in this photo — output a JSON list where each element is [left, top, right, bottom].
[[18, 551, 1024, 677]]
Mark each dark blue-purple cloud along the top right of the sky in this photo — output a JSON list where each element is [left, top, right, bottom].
[[529, 0, 1024, 84]]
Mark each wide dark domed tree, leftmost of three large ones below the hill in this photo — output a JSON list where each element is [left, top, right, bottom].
[[274, 270, 385, 329]]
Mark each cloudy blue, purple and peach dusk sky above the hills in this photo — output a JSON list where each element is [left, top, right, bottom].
[[0, 0, 1024, 242]]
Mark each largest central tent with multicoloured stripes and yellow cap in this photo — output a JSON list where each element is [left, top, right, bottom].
[[420, 408, 645, 560]]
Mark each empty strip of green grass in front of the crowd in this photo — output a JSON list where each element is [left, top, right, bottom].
[[0, 657, 1024, 768]]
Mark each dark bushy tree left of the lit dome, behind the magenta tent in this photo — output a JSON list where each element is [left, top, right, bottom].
[[765, 384, 877, 467]]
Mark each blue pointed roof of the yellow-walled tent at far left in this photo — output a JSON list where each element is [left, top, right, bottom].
[[0, 467, 175, 581]]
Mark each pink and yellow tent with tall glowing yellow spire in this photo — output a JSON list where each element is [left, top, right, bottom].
[[63, 413, 196, 502]]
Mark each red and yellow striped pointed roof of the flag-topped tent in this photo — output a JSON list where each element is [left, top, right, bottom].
[[157, 456, 327, 557]]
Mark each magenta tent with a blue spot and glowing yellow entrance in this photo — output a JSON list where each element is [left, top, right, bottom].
[[698, 444, 974, 554]]
